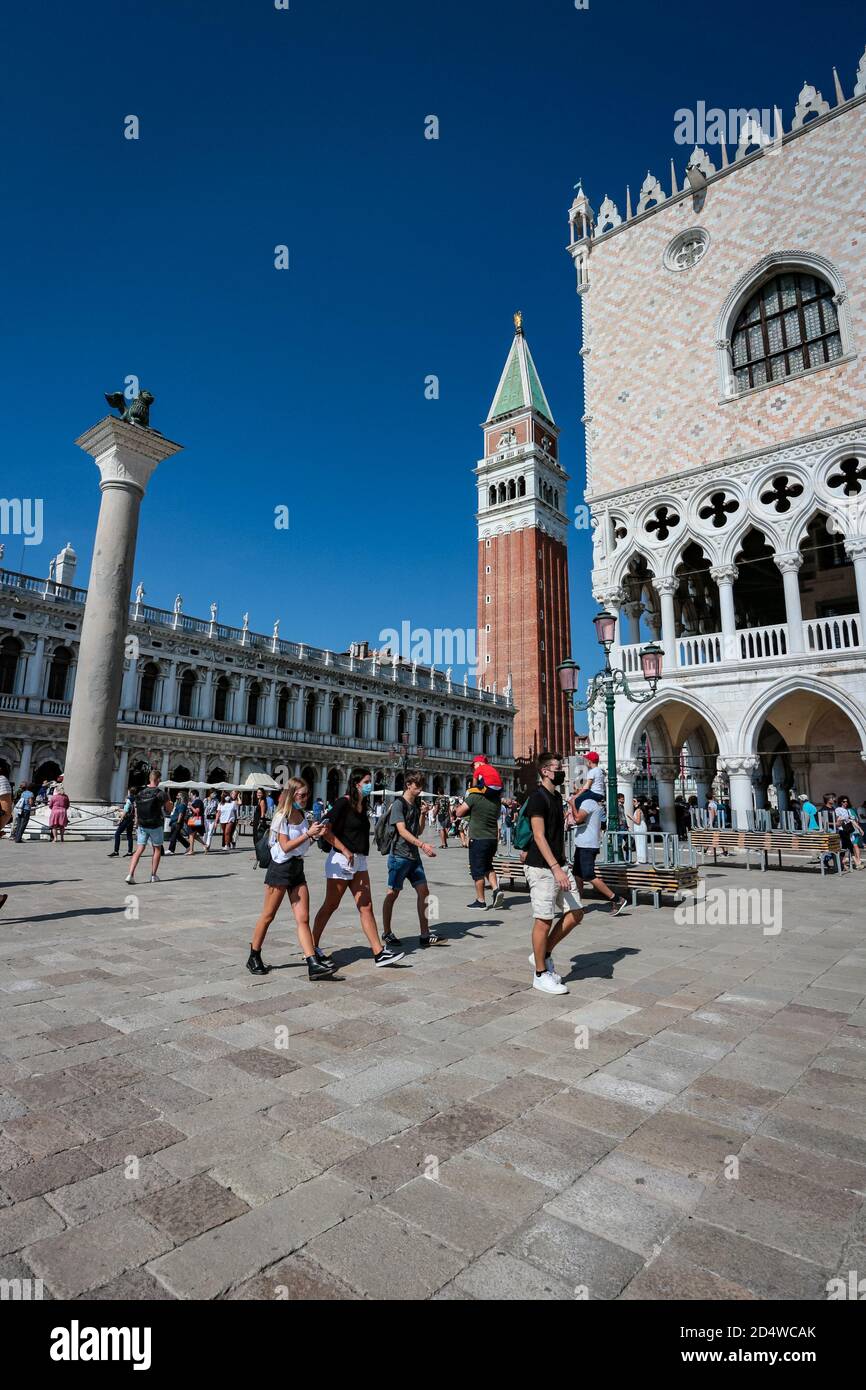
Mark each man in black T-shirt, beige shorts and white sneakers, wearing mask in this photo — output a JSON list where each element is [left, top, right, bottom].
[[525, 752, 584, 994]]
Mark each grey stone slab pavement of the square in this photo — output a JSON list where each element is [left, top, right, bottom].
[[0, 841, 866, 1300]]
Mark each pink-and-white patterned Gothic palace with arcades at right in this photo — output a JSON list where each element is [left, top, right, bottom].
[[569, 43, 866, 827]]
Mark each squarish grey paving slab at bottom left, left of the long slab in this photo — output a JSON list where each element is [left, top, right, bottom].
[[26, 1207, 171, 1298]]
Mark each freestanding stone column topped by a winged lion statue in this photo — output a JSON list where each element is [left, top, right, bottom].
[[58, 403, 182, 837]]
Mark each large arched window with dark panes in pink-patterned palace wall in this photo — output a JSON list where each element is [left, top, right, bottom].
[[731, 271, 842, 391]]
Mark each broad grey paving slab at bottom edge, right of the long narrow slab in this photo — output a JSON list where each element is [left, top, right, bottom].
[[307, 1207, 467, 1300]]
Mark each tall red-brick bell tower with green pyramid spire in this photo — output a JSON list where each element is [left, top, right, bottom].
[[475, 313, 574, 760]]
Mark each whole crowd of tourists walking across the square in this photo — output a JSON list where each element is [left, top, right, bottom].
[[0, 752, 866, 973]]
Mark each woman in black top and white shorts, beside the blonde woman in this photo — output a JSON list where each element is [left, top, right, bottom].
[[313, 767, 405, 966]]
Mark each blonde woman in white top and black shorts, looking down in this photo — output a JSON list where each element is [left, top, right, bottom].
[[246, 777, 336, 980]]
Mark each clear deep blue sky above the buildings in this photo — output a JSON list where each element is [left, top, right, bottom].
[[0, 0, 866, 717]]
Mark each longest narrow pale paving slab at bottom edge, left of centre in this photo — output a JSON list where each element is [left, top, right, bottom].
[[150, 1175, 367, 1298]]
